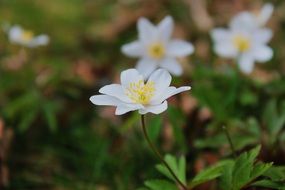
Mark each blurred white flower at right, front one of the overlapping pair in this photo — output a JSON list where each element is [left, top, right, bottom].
[[211, 26, 273, 74]]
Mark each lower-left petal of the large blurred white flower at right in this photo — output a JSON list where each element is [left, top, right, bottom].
[[214, 42, 238, 58]]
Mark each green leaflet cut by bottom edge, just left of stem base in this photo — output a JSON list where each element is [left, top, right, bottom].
[[144, 179, 178, 190]]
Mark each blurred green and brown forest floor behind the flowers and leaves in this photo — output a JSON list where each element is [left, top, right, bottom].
[[0, 0, 285, 190]]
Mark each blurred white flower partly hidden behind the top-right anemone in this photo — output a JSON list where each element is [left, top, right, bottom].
[[230, 3, 274, 29]]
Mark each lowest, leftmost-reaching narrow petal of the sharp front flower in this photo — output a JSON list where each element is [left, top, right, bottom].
[[89, 95, 121, 106]]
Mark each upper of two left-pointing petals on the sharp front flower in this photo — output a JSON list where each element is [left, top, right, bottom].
[[99, 84, 131, 103]]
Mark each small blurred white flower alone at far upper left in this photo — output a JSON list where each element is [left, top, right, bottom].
[[8, 25, 49, 48]]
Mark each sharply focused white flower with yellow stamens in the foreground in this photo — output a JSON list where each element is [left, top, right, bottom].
[[90, 69, 190, 115]]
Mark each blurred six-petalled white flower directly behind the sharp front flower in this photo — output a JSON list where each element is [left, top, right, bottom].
[[122, 16, 194, 78]]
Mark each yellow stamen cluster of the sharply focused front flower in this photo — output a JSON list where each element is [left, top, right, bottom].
[[126, 80, 155, 105]]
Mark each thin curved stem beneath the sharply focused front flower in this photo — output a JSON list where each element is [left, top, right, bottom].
[[141, 115, 188, 190]]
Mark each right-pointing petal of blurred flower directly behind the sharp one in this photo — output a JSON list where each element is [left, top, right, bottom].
[[167, 40, 194, 57]]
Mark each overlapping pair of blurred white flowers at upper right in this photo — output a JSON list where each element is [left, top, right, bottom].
[[211, 4, 273, 73]]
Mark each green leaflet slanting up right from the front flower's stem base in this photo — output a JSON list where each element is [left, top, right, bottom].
[[190, 161, 230, 187]]
